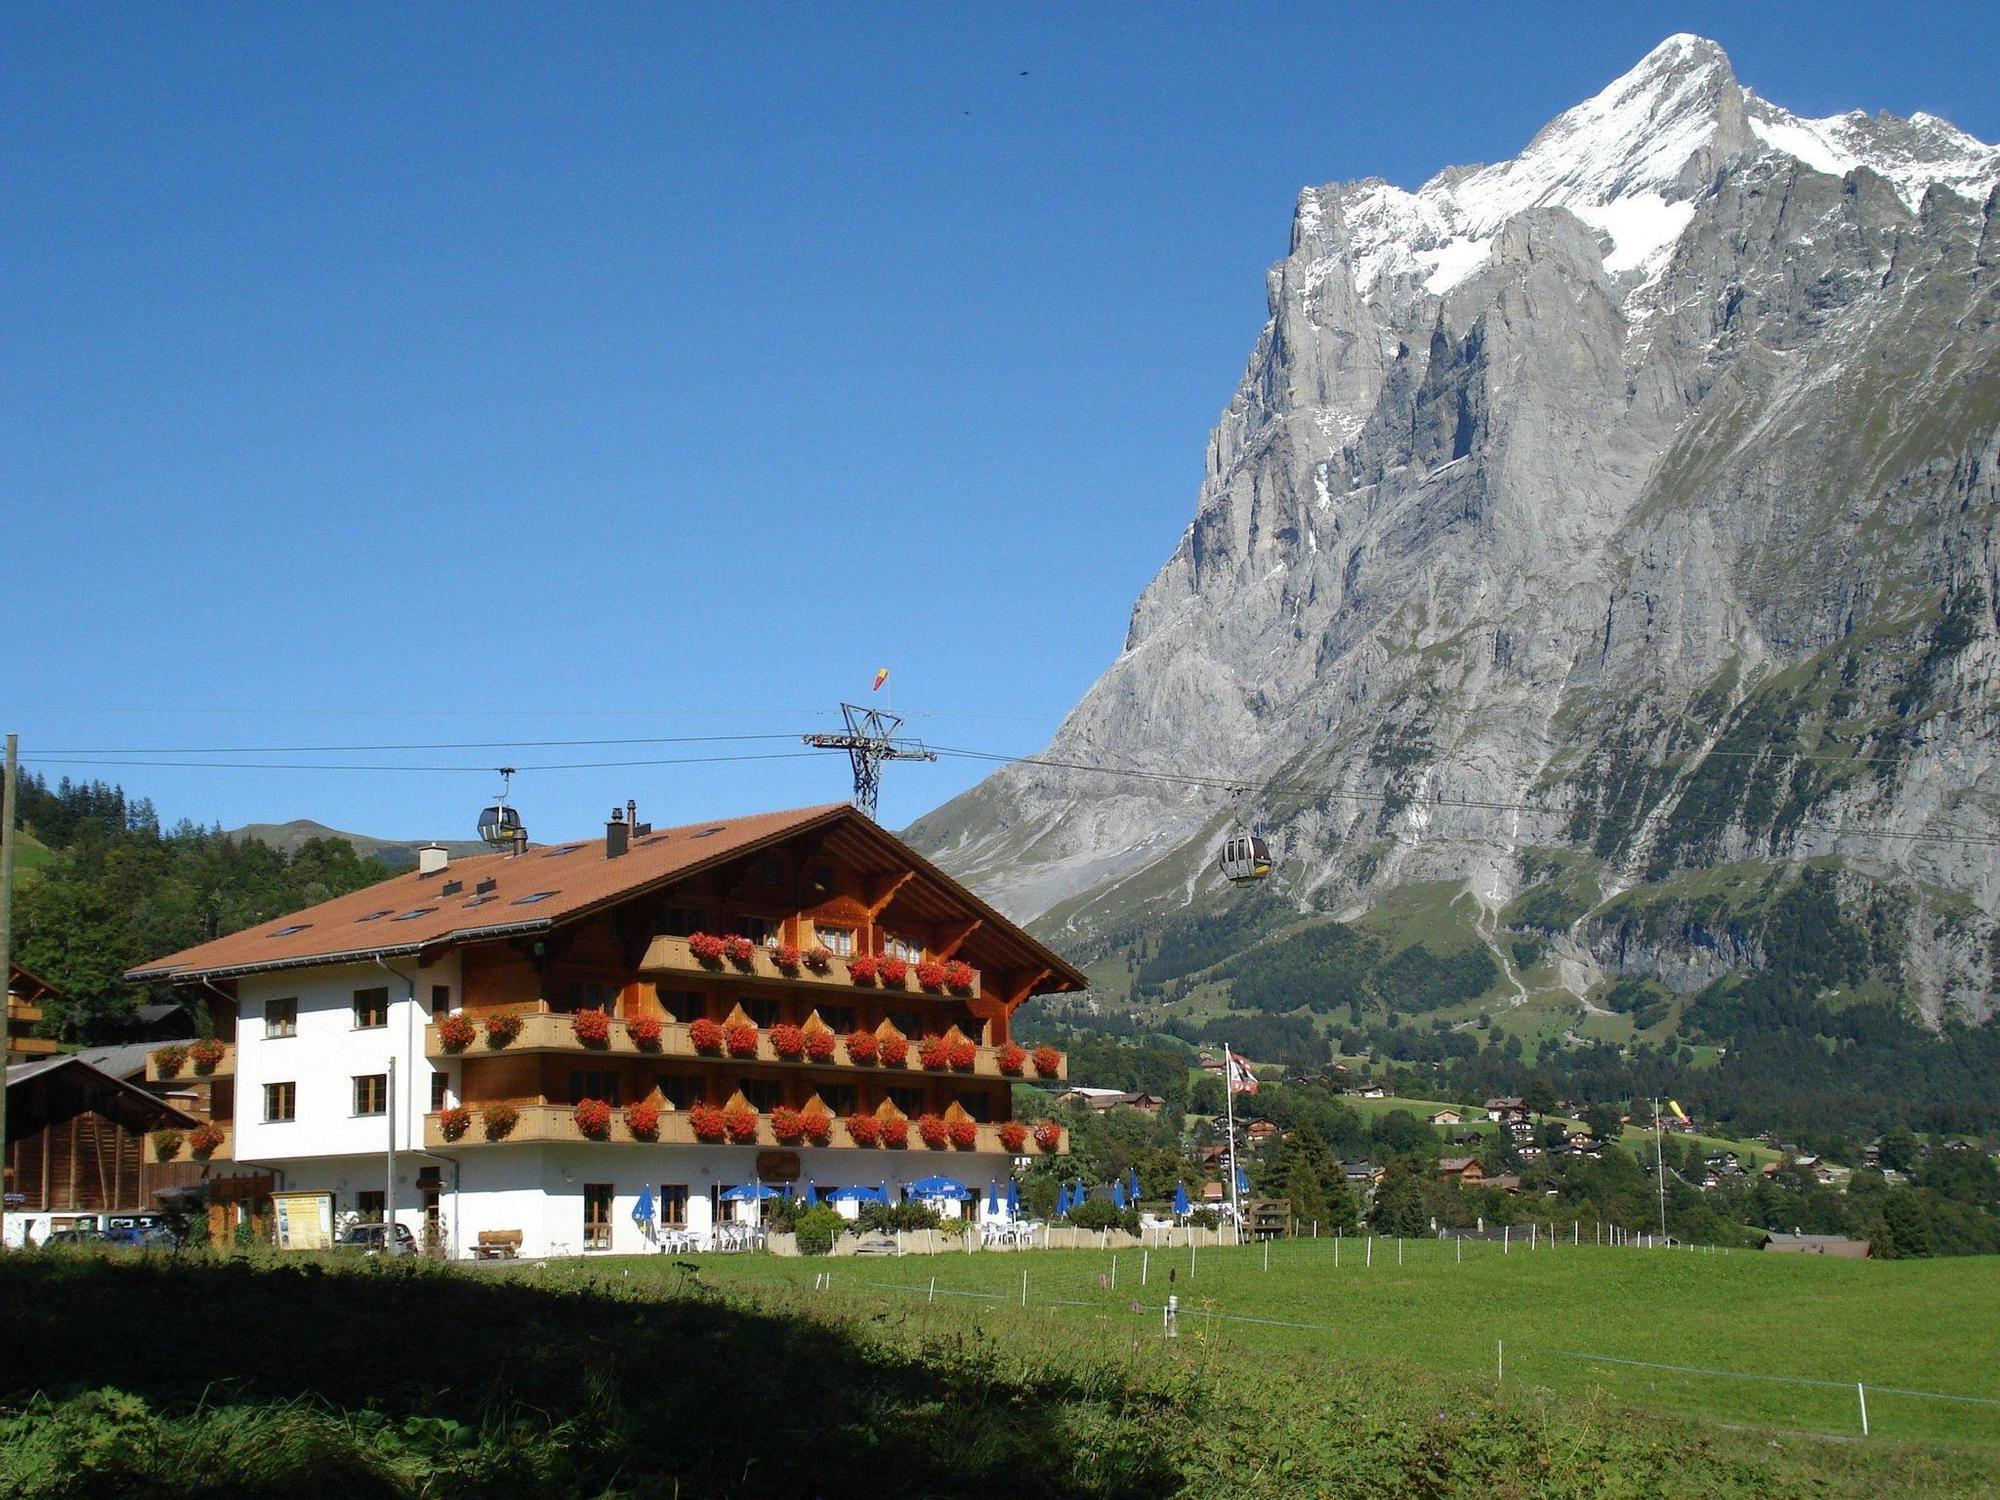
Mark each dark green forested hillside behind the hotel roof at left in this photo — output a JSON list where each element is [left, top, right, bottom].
[[3, 774, 394, 1042]]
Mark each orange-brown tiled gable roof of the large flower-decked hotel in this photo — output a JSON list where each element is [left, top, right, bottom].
[[126, 802, 1086, 988]]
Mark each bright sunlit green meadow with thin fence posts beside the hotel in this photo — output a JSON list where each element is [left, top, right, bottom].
[[564, 1238, 2000, 1454]]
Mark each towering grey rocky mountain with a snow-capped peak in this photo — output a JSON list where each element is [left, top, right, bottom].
[[912, 36, 2000, 1016]]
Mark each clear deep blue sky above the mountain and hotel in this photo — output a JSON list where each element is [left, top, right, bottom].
[[0, 4, 2000, 836]]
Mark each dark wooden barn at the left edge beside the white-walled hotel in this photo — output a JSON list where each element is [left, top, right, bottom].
[[6, 1056, 204, 1244]]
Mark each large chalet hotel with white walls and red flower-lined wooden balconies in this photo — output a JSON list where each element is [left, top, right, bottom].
[[128, 806, 1084, 1256]]
